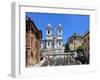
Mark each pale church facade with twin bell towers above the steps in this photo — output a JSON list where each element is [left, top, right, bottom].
[[41, 24, 63, 53]]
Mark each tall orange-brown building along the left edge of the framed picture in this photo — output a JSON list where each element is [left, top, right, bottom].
[[26, 17, 42, 67]]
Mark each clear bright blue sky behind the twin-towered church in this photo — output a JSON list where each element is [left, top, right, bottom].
[[26, 12, 90, 43]]
